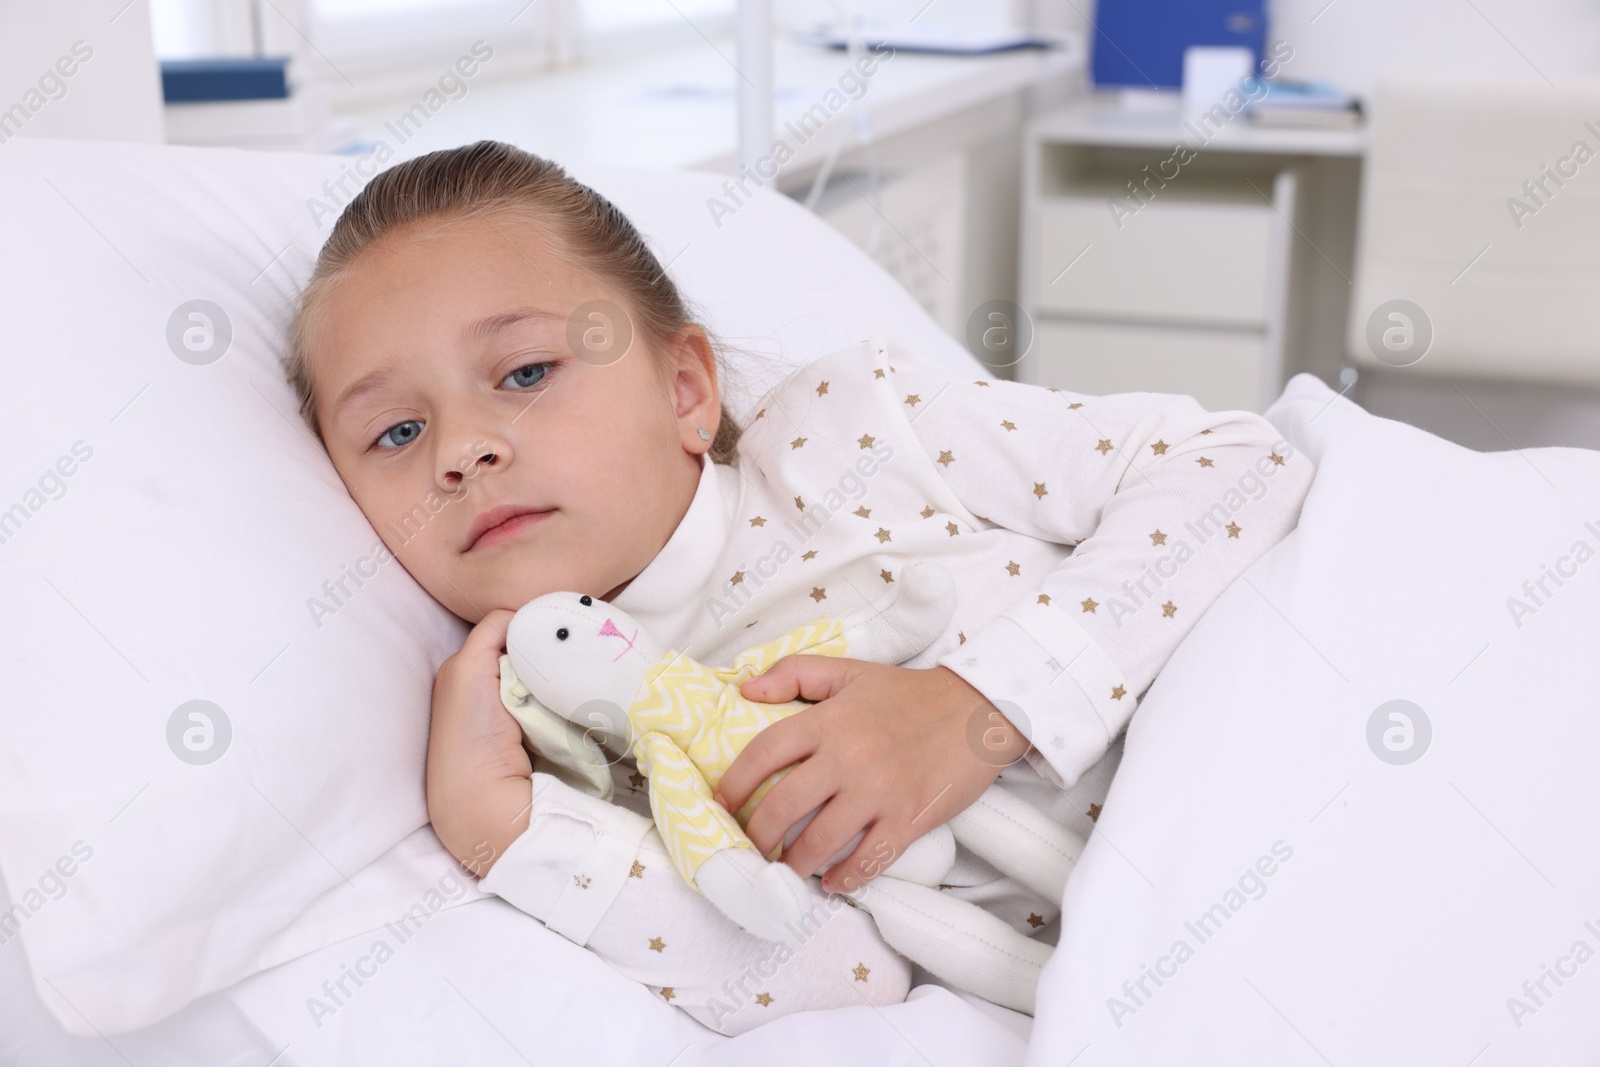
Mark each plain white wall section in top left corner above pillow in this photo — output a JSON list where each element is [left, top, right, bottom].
[[0, 0, 165, 141]]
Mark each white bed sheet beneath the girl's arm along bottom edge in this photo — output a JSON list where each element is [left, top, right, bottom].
[[0, 897, 1032, 1067]]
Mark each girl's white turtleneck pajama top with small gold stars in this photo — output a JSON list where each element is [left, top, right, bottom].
[[483, 338, 1314, 1032]]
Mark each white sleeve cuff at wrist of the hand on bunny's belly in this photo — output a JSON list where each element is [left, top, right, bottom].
[[938, 603, 1136, 789]]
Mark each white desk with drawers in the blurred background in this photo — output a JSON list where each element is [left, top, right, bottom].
[[1016, 94, 1366, 411]]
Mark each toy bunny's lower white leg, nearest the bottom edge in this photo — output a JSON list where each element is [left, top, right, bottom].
[[854, 877, 1051, 1016]]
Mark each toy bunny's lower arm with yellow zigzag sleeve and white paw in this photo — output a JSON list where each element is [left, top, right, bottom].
[[635, 733, 811, 941]]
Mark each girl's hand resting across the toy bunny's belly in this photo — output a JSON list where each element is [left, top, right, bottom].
[[717, 654, 1029, 893]]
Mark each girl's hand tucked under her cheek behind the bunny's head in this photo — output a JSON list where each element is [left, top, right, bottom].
[[427, 608, 533, 878]]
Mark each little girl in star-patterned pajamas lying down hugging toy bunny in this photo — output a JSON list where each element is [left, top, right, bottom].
[[285, 141, 1312, 1033]]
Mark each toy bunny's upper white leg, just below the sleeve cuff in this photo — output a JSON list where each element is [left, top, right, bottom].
[[949, 785, 1083, 904]]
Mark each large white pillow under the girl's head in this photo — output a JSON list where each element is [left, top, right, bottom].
[[0, 139, 982, 1033]]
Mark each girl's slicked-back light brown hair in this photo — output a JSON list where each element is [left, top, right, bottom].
[[283, 141, 741, 464]]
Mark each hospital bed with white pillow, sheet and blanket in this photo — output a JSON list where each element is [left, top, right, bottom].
[[0, 141, 1600, 1067]]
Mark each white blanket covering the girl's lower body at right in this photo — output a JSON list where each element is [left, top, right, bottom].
[[1029, 374, 1600, 1064]]
